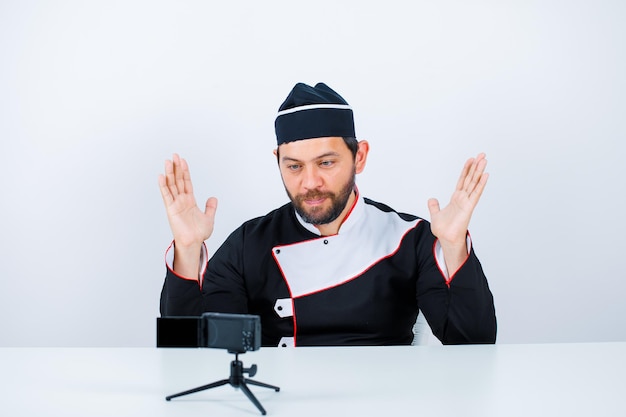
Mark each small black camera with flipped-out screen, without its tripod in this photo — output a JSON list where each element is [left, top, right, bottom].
[[157, 313, 261, 353]]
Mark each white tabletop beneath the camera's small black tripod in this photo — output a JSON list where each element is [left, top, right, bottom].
[[0, 343, 626, 417]]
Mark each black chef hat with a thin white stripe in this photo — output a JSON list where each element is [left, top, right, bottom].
[[274, 83, 356, 145]]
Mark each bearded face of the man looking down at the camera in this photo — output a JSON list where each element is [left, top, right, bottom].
[[278, 137, 360, 225]]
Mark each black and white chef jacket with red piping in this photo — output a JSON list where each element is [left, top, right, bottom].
[[161, 196, 496, 346]]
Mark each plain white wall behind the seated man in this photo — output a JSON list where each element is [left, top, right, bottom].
[[0, 0, 626, 346]]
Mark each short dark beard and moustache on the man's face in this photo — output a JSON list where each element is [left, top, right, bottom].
[[287, 173, 356, 224]]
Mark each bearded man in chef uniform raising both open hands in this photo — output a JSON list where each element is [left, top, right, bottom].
[[159, 83, 496, 346]]
